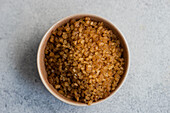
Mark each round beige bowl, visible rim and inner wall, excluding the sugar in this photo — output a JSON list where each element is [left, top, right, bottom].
[[37, 14, 130, 106]]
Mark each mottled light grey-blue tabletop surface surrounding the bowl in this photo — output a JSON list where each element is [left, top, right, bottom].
[[0, 0, 170, 113]]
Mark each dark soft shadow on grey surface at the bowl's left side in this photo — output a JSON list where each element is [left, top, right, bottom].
[[18, 37, 41, 84]]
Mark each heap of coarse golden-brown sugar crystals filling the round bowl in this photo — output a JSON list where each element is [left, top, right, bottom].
[[44, 17, 124, 105]]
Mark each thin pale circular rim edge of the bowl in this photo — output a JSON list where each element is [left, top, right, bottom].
[[37, 14, 130, 106]]
